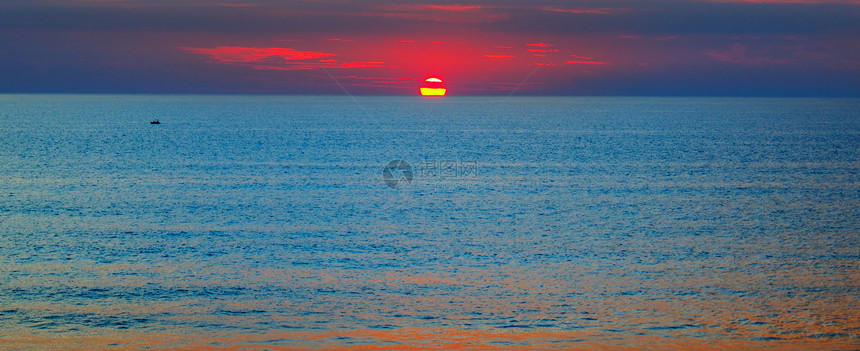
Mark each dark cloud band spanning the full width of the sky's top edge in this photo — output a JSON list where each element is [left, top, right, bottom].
[[0, 1, 860, 34]]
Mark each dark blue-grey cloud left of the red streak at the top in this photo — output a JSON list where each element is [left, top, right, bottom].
[[0, 1, 424, 34]]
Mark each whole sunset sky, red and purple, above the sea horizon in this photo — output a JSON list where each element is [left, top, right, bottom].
[[0, 0, 860, 97]]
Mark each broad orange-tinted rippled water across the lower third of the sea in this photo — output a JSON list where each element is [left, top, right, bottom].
[[0, 249, 860, 350]]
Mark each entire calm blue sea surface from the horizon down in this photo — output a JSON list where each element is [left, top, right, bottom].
[[0, 95, 860, 350]]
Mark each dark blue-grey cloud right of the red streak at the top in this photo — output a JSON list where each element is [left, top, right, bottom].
[[491, 2, 860, 34]]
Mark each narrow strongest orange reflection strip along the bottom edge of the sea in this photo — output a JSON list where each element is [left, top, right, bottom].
[[6, 328, 856, 351]]
